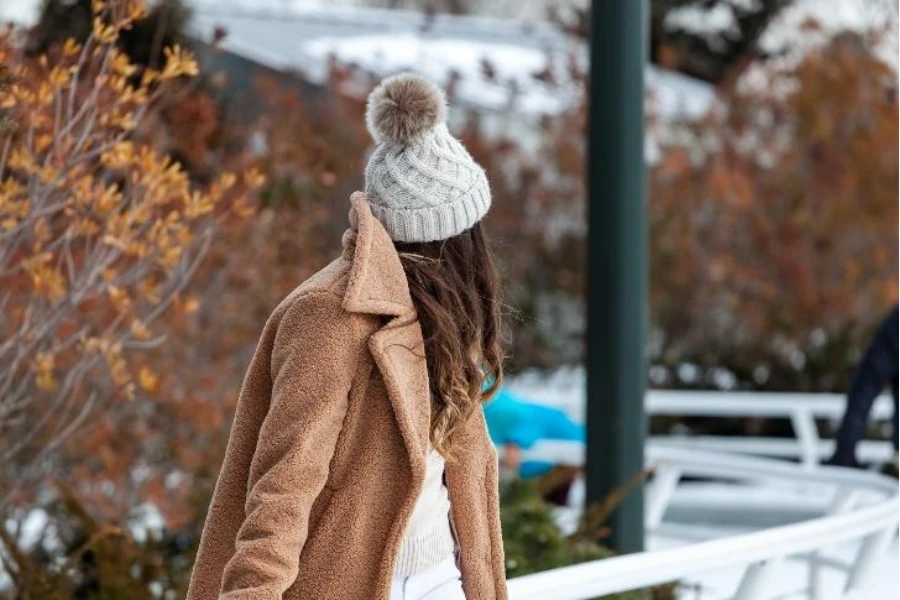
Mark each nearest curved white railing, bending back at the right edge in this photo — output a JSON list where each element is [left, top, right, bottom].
[[508, 447, 900, 600]]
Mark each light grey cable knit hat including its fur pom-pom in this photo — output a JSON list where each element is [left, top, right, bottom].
[[365, 73, 491, 242]]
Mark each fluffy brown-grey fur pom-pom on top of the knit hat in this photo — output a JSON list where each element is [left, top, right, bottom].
[[366, 73, 447, 146]]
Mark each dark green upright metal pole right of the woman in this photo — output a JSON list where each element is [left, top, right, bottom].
[[585, 0, 647, 552]]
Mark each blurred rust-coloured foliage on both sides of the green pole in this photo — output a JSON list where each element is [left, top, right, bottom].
[[463, 28, 898, 391]]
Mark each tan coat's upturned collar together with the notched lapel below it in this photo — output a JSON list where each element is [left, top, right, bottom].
[[343, 192, 431, 480]]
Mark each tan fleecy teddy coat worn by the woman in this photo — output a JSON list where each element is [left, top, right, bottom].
[[187, 192, 506, 600]]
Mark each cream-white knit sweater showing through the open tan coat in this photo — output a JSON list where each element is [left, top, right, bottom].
[[394, 443, 456, 576]]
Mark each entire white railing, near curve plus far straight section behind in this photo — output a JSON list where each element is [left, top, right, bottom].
[[500, 392, 900, 600]]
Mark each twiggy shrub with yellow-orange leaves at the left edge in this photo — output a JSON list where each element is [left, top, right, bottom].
[[0, 1, 261, 506]]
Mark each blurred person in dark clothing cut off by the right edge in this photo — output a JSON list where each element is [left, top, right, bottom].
[[827, 306, 900, 467]]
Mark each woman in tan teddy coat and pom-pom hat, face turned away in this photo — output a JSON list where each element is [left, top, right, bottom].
[[188, 74, 506, 600]]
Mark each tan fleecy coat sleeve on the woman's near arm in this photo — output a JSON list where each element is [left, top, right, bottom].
[[219, 292, 367, 600]]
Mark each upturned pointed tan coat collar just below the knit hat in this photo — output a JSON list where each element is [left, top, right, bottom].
[[343, 192, 415, 317]]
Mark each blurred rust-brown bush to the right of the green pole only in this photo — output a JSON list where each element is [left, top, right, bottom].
[[650, 34, 898, 391]]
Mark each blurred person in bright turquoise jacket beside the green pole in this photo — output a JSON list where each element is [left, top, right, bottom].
[[484, 388, 585, 504]]
